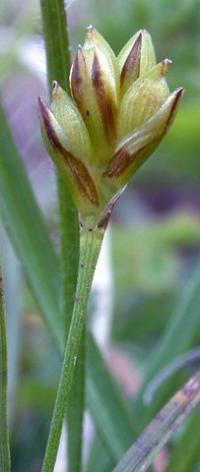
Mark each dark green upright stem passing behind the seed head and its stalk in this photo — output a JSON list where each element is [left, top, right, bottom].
[[40, 0, 82, 472]]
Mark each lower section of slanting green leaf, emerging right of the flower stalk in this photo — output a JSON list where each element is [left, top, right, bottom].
[[87, 335, 136, 462]]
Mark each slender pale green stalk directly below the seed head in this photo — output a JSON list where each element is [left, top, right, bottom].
[[43, 228, 103, 472]]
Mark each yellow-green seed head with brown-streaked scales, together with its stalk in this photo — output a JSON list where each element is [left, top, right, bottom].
[[39, 26, 183, 472]]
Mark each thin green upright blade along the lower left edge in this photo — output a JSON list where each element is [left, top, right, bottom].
[[0, 274, 11, 472]]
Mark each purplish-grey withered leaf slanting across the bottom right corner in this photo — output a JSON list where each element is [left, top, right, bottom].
[[114, 371, 200, 472]]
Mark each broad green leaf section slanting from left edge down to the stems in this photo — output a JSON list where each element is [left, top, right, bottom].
[[0, 107, 63, 346]]
